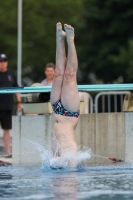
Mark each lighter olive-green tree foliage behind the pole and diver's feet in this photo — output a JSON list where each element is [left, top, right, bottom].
[[0, 0, 82, 85]]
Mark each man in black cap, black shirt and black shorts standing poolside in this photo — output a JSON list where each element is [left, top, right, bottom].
[[0, 54, 22, 158]]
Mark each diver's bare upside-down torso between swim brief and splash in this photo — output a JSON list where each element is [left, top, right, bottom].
[[52, 113, 78, 150]]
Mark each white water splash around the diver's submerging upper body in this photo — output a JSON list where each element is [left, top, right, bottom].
[[28, 140, 92, 169]]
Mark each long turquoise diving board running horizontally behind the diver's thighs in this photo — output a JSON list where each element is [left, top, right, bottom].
[[0, 84, 133, 94]]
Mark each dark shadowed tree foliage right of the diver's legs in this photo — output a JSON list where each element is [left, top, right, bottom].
[[80, 0, 133, 83]]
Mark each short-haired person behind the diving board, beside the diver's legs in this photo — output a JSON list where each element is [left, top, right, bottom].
[[41, 63, 55, 86]]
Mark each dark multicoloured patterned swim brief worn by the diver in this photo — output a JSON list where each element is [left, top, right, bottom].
[[52, 100, 80, 118]]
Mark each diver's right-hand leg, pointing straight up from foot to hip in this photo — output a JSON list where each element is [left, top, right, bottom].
[[61, 24, 80, 112]]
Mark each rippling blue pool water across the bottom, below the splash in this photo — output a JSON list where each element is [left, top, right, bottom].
[[0, 164, 133, 200]]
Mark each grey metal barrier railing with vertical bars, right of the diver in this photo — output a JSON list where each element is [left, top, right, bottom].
[[94, 91, 130, 113]]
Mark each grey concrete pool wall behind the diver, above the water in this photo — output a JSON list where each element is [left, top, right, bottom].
[[12, 112, 133, 165]]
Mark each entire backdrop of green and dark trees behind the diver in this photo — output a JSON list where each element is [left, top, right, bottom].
[[0, 0, 133, 83]]
